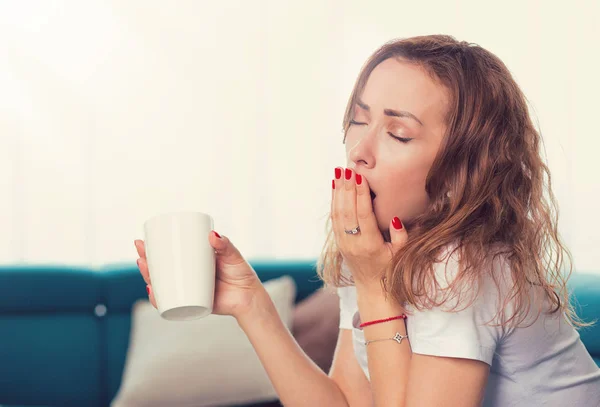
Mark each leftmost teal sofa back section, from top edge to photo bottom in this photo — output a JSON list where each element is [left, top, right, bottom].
[[0, 266, 104, 406]]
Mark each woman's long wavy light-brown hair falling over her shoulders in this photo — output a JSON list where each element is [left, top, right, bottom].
[[318, 35, 586, 326]]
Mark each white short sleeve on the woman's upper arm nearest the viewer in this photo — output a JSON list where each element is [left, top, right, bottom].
[[406, 249, 502, 366]]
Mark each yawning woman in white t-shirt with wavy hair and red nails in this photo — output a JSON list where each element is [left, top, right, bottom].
[[136, 35, 600, 407]]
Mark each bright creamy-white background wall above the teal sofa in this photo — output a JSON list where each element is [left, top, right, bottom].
[[0, 0, 600, 270]]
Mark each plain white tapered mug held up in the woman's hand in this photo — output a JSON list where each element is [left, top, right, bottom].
[[144, 212, 216, 321]]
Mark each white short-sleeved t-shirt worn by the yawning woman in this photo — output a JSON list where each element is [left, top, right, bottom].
[[337, 247, 600, 407]]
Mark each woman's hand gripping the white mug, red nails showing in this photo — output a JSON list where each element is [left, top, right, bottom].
[[134, 231, 263, 318]]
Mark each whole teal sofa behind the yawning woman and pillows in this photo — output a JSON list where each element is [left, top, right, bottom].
[[0, 261, 600, 407]]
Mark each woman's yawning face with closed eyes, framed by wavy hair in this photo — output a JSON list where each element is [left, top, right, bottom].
[[346, 58, 448, 233]]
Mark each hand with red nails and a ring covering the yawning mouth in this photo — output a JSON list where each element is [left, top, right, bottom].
[[331, 167, 408, 287]]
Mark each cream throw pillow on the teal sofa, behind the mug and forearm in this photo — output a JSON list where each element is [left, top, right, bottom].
[[111, 276, 296, 407]]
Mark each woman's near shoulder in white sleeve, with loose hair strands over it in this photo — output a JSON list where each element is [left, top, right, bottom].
[[406, 247, 510, 365]]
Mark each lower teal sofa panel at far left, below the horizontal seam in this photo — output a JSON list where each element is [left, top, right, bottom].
[[0, 313, 103, 406]]
